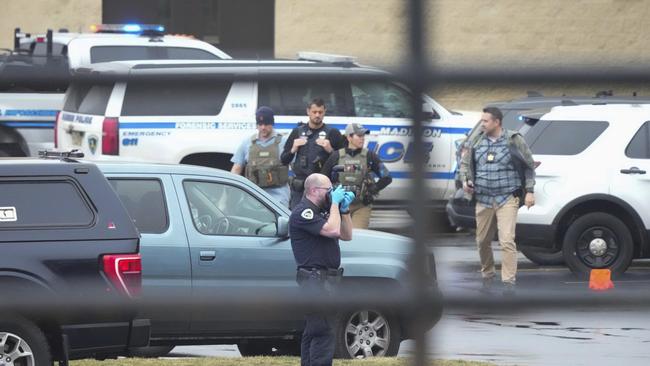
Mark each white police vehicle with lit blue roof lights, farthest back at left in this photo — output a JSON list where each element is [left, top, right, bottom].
[[0, 24, 230, 156]]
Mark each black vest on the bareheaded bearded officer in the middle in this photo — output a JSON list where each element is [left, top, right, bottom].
[[291, 123, 333, 179]]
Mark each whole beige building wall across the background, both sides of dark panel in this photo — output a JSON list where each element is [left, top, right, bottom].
[[5, 0, 650, 109]]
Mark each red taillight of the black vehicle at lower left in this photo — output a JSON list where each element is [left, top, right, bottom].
[[102, 254, 142, 297]]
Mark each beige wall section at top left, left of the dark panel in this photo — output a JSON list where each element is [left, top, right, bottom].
[[0, 0, 102, 48]]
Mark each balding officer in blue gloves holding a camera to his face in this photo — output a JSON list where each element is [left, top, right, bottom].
[[289, 173, 354, 366]]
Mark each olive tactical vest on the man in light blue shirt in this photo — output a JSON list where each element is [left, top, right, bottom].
[[246, 134, 289, 188]]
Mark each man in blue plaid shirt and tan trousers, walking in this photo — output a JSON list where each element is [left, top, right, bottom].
[[460, 107, 535, 294]]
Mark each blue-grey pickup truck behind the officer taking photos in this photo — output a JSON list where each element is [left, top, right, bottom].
[[98, 162, 442, 358]]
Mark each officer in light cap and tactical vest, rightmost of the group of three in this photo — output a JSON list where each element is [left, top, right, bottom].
[[323, 123, 393, 229]]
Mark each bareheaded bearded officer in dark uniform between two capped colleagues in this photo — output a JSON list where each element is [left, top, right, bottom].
[[281, 98, 344, 209]]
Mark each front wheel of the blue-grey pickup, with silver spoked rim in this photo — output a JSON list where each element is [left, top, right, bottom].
[[335, 310, 401, 358]]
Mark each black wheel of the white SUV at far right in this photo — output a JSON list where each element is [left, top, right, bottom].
[[562, 212, 634, 276]]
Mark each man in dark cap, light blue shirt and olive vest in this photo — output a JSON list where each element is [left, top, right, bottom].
[[230, 106, 289, 206]]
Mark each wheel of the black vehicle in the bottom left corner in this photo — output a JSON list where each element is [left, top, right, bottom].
[[0, 316, 52, 366]]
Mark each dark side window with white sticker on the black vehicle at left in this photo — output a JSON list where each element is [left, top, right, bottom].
[[0, 180, 95, 230]]
